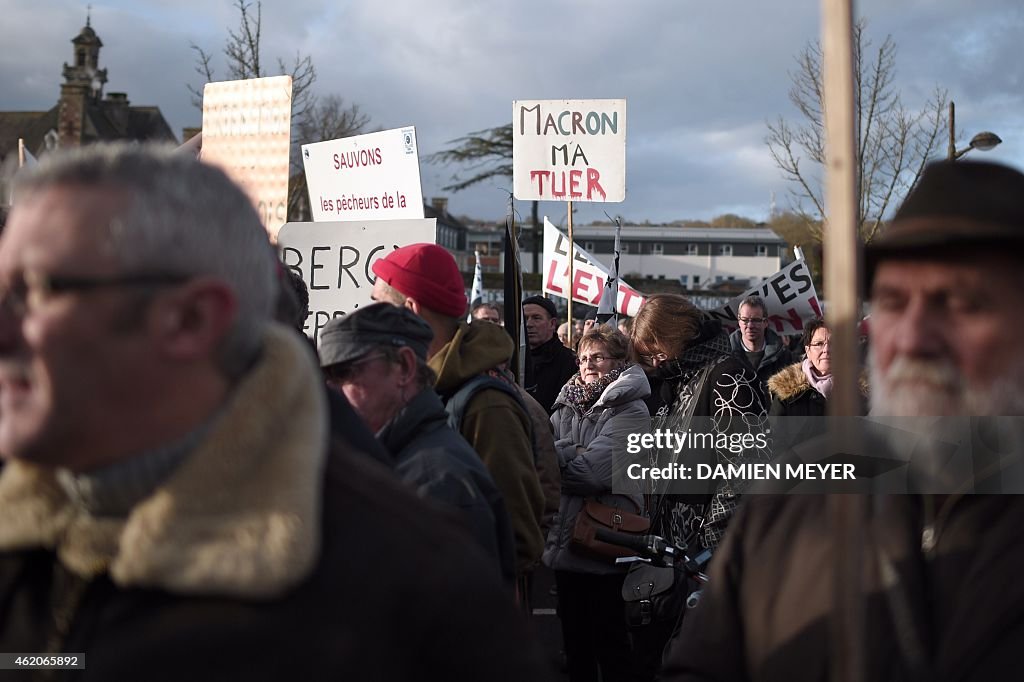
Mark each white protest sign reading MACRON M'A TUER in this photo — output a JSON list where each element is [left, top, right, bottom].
[[512, 99, 626, 202]]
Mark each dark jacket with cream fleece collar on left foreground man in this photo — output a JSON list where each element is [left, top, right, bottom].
[[0, 331, 549, 682]]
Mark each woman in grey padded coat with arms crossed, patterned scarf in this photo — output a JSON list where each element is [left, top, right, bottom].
[[544, 327, 650, 682]]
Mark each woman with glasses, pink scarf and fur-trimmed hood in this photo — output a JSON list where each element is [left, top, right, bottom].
[[768, 318, 866, 417]]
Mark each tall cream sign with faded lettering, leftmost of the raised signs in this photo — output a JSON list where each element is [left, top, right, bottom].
[[202, 76, 292, 239]]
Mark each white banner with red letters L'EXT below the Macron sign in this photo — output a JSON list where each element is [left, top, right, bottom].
[[544, 217, 645, 317]]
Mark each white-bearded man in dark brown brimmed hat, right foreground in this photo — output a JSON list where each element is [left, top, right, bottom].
[[662, 157, 1024, 682]]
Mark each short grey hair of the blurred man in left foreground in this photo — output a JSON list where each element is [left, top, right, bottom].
[[15, 143, 280, 378]]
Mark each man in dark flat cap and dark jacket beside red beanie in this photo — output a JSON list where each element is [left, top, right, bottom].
[[319, 303, 515, 584]]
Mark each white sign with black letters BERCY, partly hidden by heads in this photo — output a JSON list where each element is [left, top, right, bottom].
[[278, 218, 437, 341]]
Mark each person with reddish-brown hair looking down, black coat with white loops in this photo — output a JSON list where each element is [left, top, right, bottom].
[[631, 294, 768, 680]]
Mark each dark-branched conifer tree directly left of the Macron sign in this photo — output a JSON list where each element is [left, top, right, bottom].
[[426, 123, 543, 272]]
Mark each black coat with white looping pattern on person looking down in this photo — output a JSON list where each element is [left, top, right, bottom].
[[651, 322, 770, 550]]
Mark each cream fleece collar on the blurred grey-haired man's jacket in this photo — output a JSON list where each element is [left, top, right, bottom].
[[0, 326, 328, 597]]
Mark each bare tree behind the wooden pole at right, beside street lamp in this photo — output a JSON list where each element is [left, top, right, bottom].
[[765, 19, 947, 242]]
